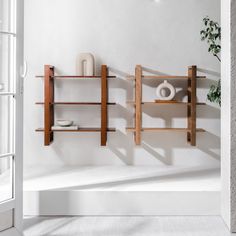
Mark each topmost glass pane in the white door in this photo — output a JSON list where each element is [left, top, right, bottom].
[[0, 0, 12, 31]]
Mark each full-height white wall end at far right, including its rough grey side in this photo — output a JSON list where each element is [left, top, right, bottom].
[[221, 0, 236, 232]]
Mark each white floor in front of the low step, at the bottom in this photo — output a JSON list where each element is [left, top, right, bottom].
[[24, 216, 234, 236]]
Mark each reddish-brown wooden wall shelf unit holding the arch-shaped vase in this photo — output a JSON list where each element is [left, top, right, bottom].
[[36, 65, 116, 146]]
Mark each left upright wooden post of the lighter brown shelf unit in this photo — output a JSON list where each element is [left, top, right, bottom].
[[134, 65, 142, 145]]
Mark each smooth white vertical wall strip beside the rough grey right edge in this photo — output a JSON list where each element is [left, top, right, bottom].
[[221, 0, 231, 230]]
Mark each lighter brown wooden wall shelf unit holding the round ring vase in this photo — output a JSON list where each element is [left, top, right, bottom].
[[126, 65, 206, 146]]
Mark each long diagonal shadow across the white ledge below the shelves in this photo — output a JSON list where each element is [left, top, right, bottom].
[[31, 167, 220, 192]]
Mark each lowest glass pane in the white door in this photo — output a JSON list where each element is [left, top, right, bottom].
[[0, 157, 13, 203]]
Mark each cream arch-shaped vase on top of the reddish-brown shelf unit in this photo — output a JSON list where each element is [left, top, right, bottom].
[[76, 53, 95, 76]]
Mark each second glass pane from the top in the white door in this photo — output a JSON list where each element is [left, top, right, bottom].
[[0, 33, 14, 93]]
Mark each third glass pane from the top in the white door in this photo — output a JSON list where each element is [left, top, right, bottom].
[[0, 95, 14, 155]]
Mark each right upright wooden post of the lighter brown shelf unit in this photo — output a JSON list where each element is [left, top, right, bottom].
[[187, 66, 197, 146]]
